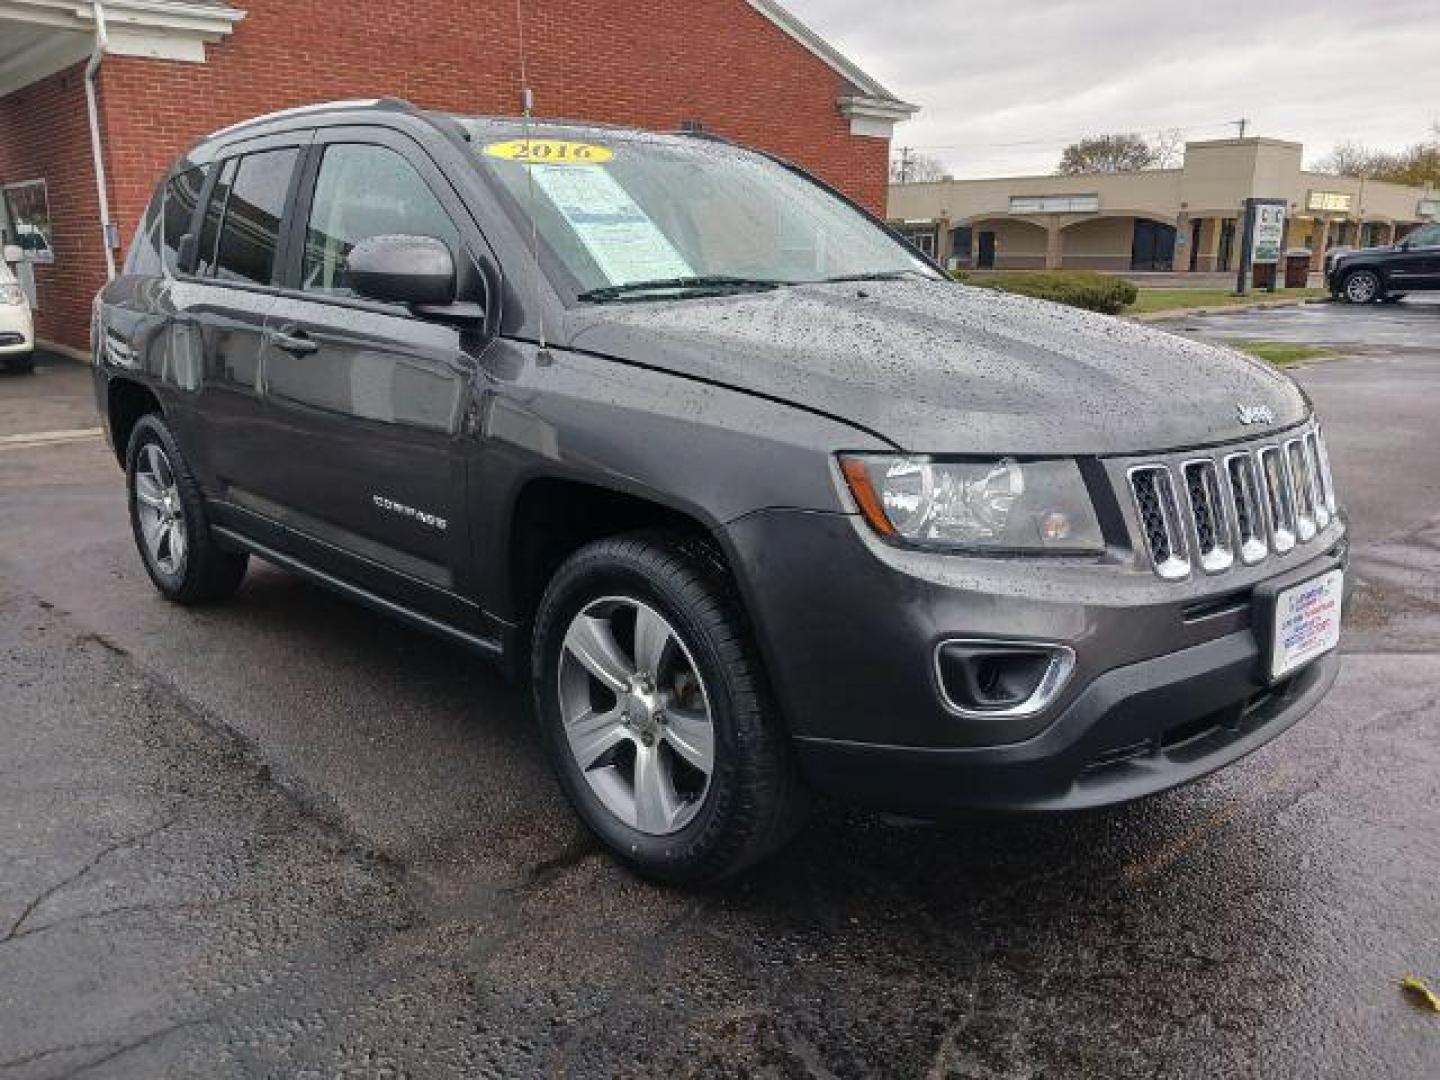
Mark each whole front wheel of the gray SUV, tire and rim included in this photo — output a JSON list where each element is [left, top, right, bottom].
[[531, 534, 804, 884]]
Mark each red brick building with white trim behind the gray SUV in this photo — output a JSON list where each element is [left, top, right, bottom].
[[0, 0, 916, 350]]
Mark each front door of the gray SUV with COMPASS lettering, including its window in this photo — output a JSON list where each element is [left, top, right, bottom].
[[256, 128, 482, 621]]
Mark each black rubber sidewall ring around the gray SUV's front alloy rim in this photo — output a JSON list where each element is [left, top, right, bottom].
[[531, 553, 742, 877]]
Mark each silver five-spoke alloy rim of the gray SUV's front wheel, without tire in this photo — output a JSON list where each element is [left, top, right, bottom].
[[559, 596, 716, 837]]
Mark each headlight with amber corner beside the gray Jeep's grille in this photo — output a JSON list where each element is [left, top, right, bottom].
[[840, 454, 1104, 552]]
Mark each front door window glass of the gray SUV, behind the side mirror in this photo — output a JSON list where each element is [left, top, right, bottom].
[[302, 143, 459, 297]]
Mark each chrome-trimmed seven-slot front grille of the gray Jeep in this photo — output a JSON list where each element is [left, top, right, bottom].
[[1128, 428, 1336, 580]]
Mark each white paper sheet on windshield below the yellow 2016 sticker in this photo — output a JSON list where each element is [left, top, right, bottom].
[[533, 164, 694, 285]]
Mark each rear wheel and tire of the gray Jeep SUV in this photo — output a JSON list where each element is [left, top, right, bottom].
[[125, 413, 249, 605]]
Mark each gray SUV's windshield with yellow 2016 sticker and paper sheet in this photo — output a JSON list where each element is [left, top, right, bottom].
[[465, 121, 935, 300]]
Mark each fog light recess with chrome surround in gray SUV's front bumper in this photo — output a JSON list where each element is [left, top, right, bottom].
[[935, 641, 1076, 719]]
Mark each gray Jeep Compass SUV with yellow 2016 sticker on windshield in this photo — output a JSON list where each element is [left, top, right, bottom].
[[94, 101, 1346, 881]]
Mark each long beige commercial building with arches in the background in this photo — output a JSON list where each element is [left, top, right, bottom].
[[888, 138, 1440, 272]]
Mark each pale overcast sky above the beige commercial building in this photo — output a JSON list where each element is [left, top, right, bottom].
[[782, 0, 1440, 177]]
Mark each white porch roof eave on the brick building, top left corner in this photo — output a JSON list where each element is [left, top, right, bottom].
[[0, 0, 245, 95]]
